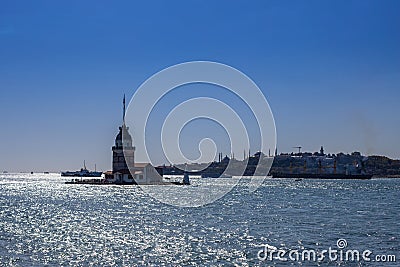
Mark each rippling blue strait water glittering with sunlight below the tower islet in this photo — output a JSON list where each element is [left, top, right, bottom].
[[0, 174, 400, 266]]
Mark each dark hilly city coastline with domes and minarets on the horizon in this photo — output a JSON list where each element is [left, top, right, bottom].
[[156, 147, 400, 179]]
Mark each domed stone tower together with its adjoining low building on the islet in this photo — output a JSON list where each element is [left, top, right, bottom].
[[105, 95, 163, 184]]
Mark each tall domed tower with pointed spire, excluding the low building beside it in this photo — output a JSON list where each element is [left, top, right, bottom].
[[112, 95, 135, 176]]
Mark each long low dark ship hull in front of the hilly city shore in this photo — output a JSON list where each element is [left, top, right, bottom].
[[272, 173, 372, 180]]
